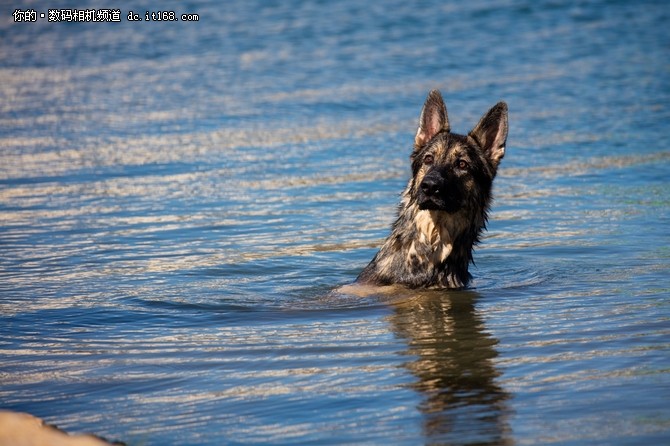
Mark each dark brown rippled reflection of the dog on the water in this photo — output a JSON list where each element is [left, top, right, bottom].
[[390, 291, 512, 444]]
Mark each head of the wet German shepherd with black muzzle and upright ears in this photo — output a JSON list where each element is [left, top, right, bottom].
[[411, 90, 507, 213]]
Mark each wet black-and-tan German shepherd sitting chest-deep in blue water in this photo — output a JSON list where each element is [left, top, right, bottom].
[[356, 90, 507, 289]]
